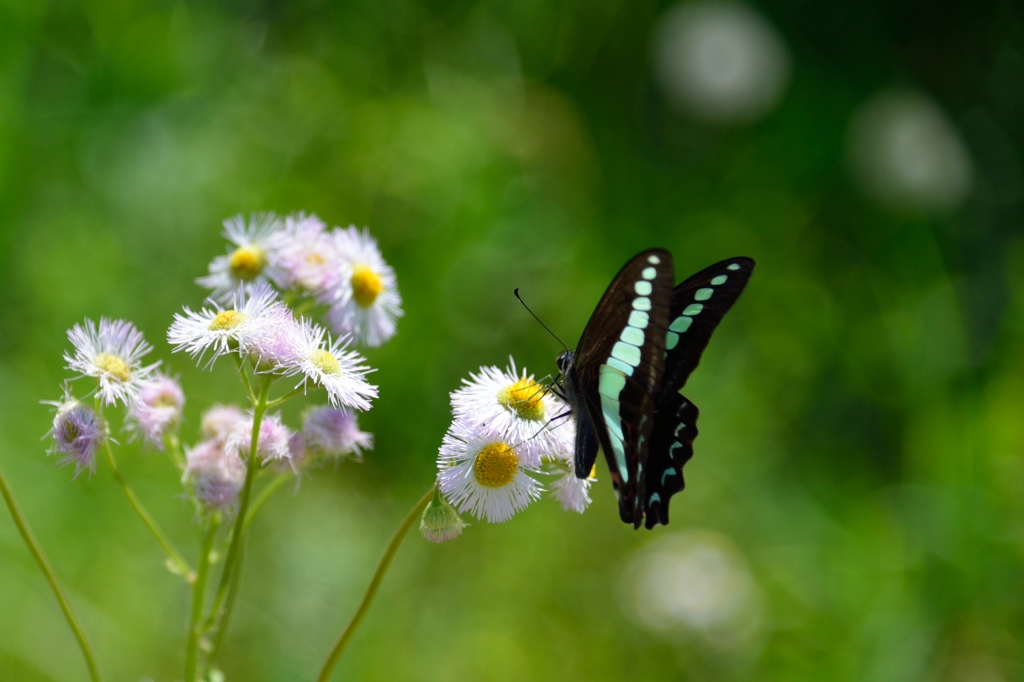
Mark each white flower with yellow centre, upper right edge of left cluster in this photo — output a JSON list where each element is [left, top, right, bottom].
[[319, 226, 402, 346]]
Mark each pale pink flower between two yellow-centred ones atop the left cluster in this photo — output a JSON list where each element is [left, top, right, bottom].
[[274, 213, 338, 294]]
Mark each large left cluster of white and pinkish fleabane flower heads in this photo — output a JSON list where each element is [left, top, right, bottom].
[[49, 213, 393, 514]]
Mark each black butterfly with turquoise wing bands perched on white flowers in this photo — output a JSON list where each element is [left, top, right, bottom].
[[555, 249, 754, 528]]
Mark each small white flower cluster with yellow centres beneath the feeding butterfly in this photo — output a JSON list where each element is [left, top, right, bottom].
[[421, 359, 593, 542]]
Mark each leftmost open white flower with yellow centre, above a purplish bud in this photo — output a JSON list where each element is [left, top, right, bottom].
[[63, 317, 160, 404]]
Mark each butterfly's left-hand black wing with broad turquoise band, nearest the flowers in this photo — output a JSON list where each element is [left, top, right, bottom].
[[566, 249, 674, 527]]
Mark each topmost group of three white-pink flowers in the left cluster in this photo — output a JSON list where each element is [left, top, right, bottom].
[[197, 213, 402, 346]]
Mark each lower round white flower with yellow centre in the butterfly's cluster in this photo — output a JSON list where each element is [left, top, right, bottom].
[[437, 419, 544, 523]]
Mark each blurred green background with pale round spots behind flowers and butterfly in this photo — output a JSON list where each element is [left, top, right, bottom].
[[0, 0, 1024, 682]]
